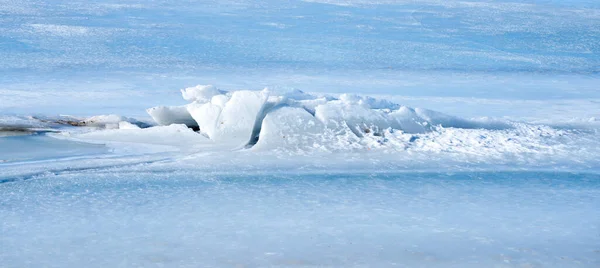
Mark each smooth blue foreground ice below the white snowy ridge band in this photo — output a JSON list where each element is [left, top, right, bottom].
[[0, 171, 600, 267]]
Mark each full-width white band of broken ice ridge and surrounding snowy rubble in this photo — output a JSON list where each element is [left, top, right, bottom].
[[4, 86, 600, 168]]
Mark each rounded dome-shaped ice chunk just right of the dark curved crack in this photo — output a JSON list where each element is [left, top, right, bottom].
[[253, 107, 325, 150]]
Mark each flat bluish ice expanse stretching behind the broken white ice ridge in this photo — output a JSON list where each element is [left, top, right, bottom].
[[0, 0, 600, 116]]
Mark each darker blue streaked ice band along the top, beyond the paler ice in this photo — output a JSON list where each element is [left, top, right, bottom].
[[0, 0, 600, 73]]
